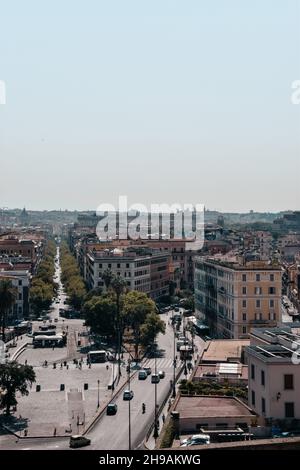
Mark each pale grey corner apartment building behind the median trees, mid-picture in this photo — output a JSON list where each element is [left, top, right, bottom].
[[85, 248, 169, 300]]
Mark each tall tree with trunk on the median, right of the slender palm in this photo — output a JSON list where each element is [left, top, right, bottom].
[[123, 291, 156, 360]]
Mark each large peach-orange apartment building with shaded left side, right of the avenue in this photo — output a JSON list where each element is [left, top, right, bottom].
[[195, 257, 281, 339]]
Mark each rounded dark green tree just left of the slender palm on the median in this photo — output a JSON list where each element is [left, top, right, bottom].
[[83, 295, 117, 337]]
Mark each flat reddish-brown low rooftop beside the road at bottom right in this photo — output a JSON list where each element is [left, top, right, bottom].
[[176, 395, 255, 418]]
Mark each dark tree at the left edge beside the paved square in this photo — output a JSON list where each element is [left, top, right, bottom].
[[0, 361, 35, 414]]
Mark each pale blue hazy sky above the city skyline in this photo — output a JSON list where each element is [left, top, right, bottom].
[[0, 0, 300, 211]]
